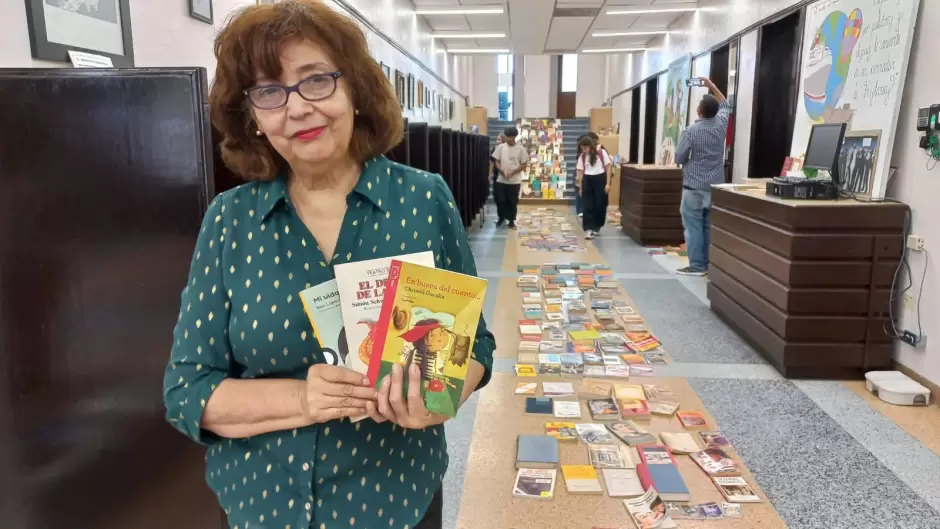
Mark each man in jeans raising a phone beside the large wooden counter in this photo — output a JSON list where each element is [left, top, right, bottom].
[[676, 77, 731, 276]]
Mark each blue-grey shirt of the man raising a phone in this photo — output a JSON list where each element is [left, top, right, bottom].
[[676, 100, 731, 190]]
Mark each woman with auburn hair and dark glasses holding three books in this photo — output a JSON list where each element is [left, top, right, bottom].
[[164, 0, 495, 529]]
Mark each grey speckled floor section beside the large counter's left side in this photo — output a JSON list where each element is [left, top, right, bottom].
[[620, 278, 765, 364]]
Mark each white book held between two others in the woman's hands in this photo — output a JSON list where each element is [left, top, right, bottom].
[[333, 252, 434, 422]]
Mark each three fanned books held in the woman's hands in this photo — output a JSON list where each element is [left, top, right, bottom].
[[296, 251, 487, 420]]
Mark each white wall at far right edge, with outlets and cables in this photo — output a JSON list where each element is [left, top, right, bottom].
[[888, 0, 940, 384]]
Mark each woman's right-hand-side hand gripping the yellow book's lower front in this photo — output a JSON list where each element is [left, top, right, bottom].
[[366, 364, 449, 430]]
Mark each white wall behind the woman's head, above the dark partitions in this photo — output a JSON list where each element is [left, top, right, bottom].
[[0, 0, 472, 129]]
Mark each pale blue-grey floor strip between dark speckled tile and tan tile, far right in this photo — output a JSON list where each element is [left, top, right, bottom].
[[794, 380, 940, 512]]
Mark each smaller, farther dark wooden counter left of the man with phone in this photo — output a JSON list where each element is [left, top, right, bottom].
[[620, 165, 685, 246]]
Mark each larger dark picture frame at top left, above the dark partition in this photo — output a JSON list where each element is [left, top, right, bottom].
[[25, 0, 134, 68]]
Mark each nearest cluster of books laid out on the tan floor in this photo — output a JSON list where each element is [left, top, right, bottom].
[[513, 380, 761, 528]]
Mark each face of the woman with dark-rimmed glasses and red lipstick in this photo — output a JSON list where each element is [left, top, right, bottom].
[[252, 40, 354, 167]]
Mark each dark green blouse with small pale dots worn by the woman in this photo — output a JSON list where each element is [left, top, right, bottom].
[[164, 157, 495, 529]]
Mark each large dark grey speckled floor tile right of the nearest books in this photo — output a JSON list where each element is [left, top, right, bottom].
[[689, 378, 940, 529]]
